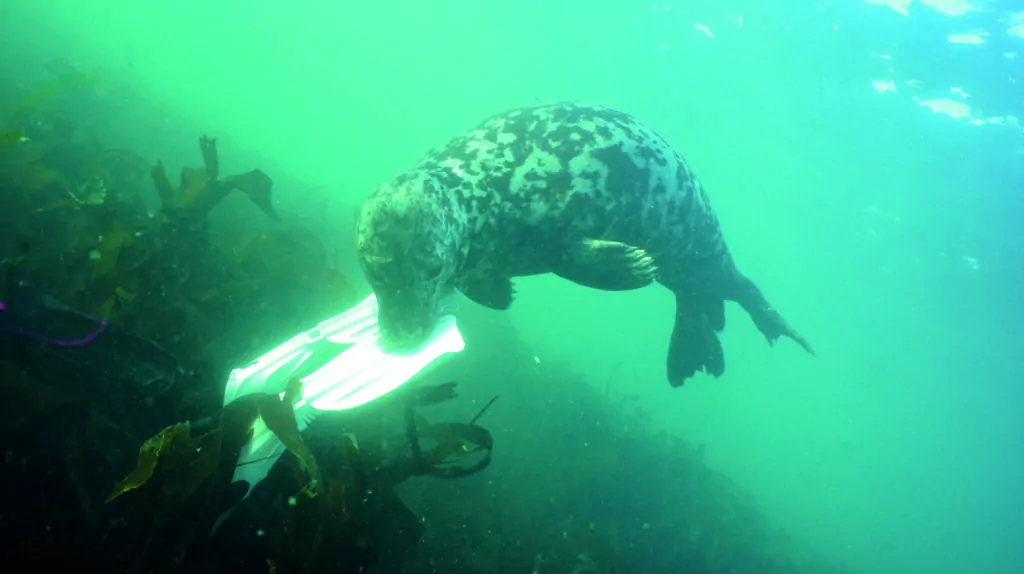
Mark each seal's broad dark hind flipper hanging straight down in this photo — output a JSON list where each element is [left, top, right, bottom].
[[668, 292, 725, 387]]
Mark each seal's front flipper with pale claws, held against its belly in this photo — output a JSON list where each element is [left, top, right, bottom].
[[553, 239, 657, 291]]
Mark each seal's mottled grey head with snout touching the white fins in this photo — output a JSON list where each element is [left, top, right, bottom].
[[356, 177, 460, 348]]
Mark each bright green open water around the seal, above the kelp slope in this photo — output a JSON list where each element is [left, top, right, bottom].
[[9, 0, 1024, 574]]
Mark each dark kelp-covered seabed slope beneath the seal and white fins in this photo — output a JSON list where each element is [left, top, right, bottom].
[[0, 69, 847, 574]]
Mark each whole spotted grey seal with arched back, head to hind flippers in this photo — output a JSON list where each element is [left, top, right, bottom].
[[357, 102, 813, 386]]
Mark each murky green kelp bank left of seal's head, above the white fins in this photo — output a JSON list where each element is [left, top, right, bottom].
[[0, 94, 354, 374]]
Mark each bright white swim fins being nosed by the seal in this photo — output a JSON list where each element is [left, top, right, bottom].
[[214, 295, 465, 530]]
